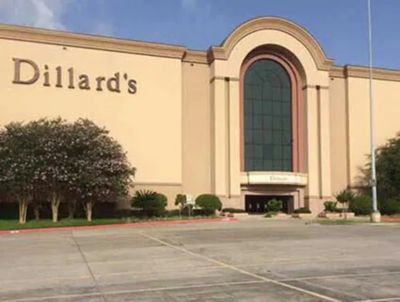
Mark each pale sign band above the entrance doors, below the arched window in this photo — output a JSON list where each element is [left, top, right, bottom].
[[241, 172, 307, 186]]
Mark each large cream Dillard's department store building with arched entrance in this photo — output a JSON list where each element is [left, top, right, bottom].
[[0, 18, 400, 213]]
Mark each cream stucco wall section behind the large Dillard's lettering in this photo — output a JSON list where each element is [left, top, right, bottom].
[[0, 40, 182, 186]]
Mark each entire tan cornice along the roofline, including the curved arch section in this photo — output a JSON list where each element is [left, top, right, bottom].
[[0, 22, 400, 81]]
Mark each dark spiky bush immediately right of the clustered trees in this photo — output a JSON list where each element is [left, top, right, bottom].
[[132, 190, 168, 217]]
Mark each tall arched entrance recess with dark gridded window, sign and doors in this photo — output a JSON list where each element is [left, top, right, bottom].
[[241, 47, 306, 213]]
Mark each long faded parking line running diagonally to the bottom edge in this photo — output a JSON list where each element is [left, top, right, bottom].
[[139, 231, 340, 302]]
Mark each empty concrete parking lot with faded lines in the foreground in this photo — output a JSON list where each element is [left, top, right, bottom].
[[0, 219, 400, 302]]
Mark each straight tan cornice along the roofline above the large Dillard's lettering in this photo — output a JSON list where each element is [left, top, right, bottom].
[[0, 24, 186, 59]]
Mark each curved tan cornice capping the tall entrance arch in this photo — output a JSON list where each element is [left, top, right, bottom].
[[209, 17, 333, 71]]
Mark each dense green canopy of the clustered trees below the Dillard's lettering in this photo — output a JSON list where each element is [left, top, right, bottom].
[[0, 118, 135, 222]]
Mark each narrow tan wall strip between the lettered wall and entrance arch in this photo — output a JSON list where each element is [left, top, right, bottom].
[[182, 63, 211, 195]]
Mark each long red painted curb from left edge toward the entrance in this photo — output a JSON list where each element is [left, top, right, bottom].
[[0, 218, 237, 235]]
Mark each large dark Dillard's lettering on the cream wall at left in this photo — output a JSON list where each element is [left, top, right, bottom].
[[13, 58, 137, 94]]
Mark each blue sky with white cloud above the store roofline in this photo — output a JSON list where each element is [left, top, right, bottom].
[[0, 0, 400, 69]]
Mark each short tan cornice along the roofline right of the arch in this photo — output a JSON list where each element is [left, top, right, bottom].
[[329, 65, 400, 82]]
